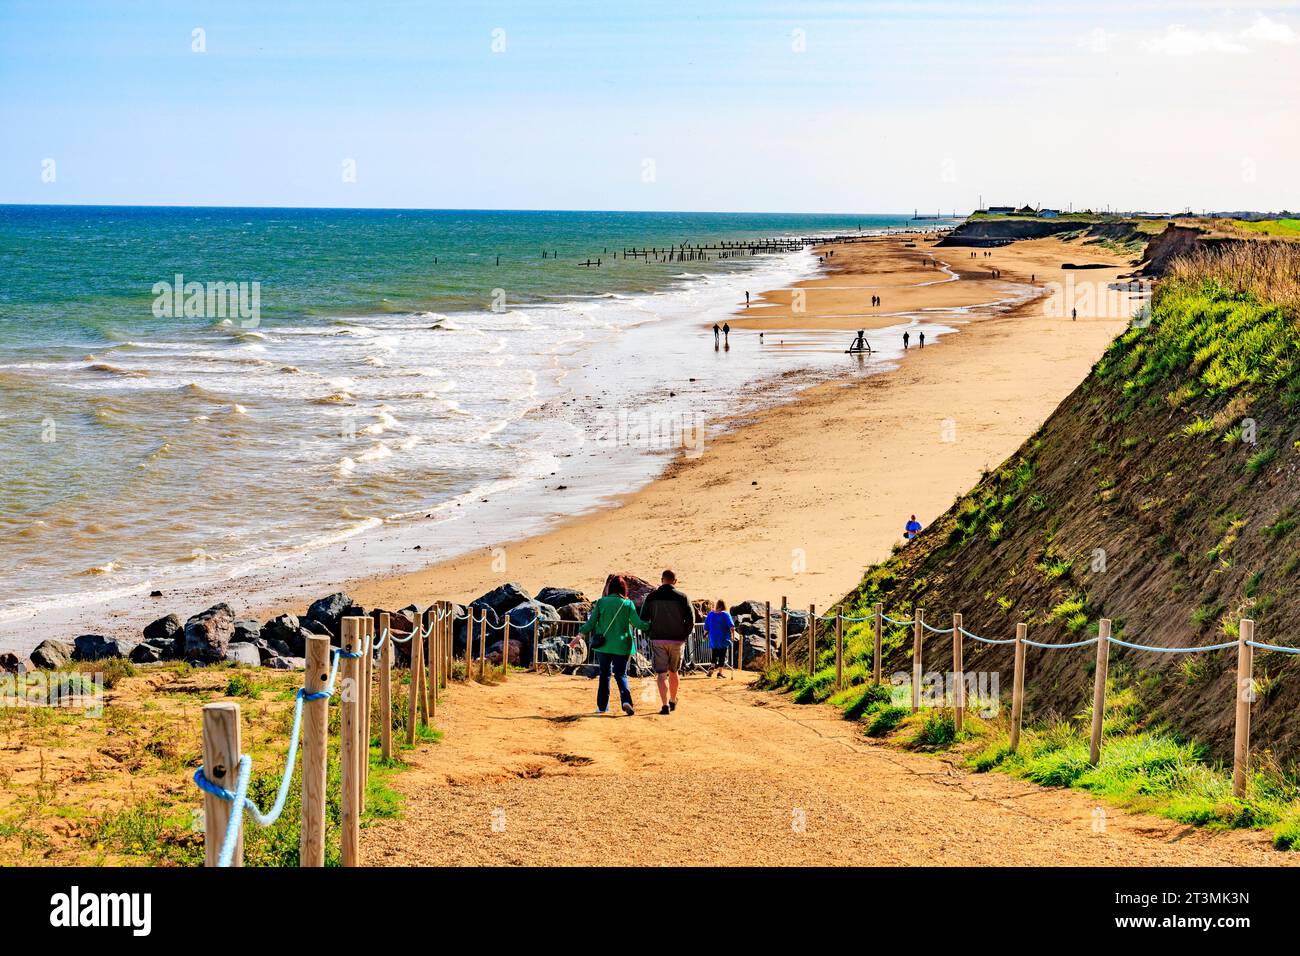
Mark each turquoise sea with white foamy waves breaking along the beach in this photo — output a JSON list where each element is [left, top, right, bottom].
[[0, 207, 956, 632]]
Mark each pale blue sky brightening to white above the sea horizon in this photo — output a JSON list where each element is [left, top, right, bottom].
[[0, 0, 1300, 212]]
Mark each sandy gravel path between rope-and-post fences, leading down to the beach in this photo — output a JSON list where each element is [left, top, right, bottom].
[[361, 674, 1284, 866]]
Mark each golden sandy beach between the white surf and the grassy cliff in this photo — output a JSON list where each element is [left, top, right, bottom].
[[348, 237, 1136, 616]]
